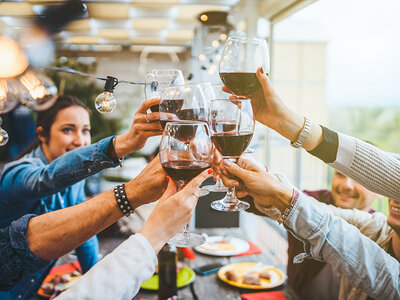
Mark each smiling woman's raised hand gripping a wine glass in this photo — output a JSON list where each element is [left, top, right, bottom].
[[115, 98, 162, 157]]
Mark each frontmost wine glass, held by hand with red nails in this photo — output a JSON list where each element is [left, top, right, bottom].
[[160, 121, 213, 247]]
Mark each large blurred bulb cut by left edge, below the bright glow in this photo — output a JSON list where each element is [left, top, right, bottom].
[[0, 78, 22, 114]]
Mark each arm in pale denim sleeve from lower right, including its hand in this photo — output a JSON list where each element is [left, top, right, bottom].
[[225, 156, 400, 299]]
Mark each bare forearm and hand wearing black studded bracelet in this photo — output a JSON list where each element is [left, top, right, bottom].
[[26, 157, 166, 261]]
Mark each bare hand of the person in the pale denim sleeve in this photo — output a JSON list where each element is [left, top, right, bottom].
[[220, 156, 292, 212]]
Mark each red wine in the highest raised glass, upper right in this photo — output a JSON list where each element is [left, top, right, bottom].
[[219, 72, 261, 96]]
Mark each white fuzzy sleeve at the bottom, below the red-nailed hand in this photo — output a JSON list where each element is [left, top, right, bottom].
[[57, 233, 157, 300]]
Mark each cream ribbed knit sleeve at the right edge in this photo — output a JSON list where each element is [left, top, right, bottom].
[[329, 133, 400, 201]]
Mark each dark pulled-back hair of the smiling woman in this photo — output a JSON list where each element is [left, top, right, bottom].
[[16, 95, 90, 160]]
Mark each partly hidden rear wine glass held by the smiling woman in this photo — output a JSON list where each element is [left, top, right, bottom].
[[144, 69, 185, 112]]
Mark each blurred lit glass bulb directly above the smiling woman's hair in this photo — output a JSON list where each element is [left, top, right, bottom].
[[19, 71, 58, 111]]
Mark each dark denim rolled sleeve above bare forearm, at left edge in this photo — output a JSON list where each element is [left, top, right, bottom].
[[0, 215, 49, 291]]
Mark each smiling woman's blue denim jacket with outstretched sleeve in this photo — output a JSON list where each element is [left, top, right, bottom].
[[0, 137, 117, 299]]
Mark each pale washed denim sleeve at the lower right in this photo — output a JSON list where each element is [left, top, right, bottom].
[[284, 193, 400, 299]]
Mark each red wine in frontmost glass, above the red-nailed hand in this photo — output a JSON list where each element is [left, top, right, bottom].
[[162, 161, 211, 183]]
